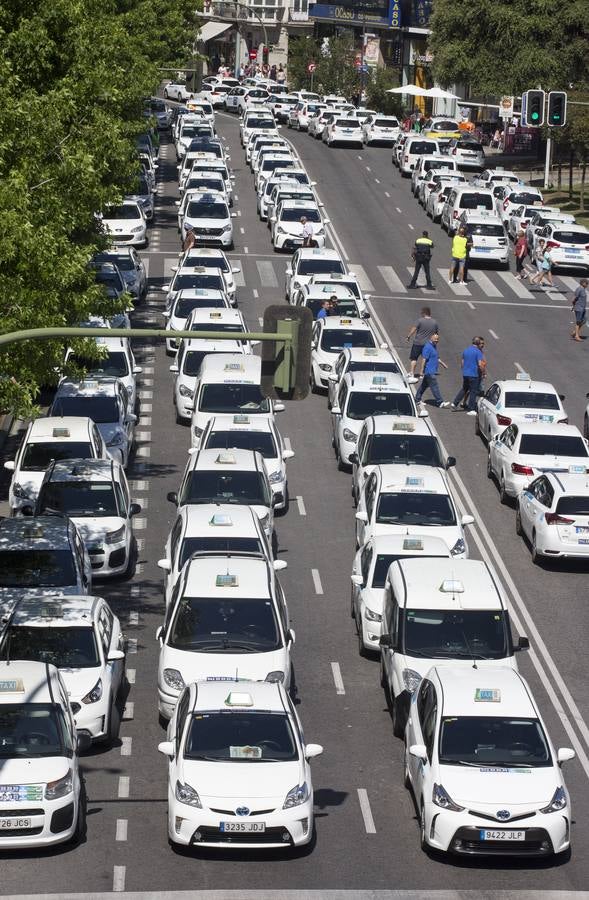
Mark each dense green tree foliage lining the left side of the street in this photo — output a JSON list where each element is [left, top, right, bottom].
[[0, 0, 195, 413]]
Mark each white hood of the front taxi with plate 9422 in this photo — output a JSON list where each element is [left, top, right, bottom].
[[439, 765, 562, 812]]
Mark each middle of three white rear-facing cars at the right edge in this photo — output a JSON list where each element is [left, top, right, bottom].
[[487, 423, 589, 503]]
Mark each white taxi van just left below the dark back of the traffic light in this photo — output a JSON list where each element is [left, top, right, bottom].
[[191, 353, 284, 448]]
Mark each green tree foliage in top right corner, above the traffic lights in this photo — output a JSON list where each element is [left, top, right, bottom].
[[429, 0, 589, 96]]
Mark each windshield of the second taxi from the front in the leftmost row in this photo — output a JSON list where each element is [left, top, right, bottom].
[[2, 625, 100, 669]]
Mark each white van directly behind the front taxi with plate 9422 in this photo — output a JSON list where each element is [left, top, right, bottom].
[[380, 558, 529, 737]]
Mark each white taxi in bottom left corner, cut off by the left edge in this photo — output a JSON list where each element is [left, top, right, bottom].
[[0, 660, 90, 852]]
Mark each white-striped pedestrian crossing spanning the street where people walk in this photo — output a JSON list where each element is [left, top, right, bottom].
[[145, 253, 579, 307]]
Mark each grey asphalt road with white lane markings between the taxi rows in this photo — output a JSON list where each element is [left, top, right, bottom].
[[0, 114, 589, 897]]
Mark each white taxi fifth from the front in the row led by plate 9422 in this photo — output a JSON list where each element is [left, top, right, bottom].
[[350, 411, 456, 502]]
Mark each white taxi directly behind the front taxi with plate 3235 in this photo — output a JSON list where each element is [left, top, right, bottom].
[[156, 553, 294, 719]]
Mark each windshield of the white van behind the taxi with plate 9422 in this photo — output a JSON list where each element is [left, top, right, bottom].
[[401, 609, 509, 659]]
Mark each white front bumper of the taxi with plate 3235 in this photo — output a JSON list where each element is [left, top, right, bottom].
[[168, 799, 313, 851]]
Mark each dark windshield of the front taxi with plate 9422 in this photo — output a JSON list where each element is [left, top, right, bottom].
[[439, 716, 552, 769]]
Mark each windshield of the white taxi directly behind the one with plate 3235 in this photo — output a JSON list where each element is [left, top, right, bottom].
[[168, 597, 282, 654]]
